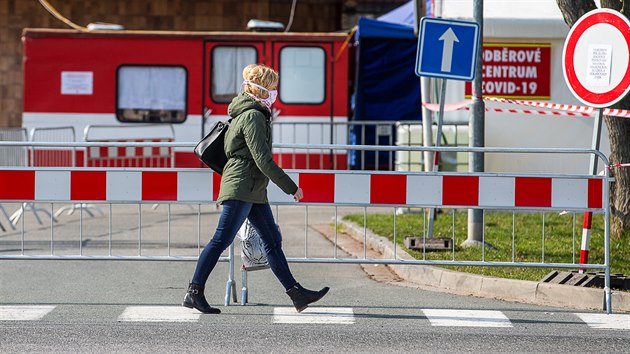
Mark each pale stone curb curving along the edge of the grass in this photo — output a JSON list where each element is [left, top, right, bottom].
[[337, 218, 630, 312]]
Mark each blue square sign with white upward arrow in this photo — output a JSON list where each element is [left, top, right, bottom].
[[416, 17, 479, 81]]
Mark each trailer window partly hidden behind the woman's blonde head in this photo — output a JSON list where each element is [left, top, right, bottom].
[[211, 46, 258, 103]]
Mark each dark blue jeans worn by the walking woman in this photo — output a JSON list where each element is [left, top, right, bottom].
[[192, 200, 297, 290]]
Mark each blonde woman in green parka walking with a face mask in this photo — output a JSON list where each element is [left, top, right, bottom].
[[183, 64, 329, 313]]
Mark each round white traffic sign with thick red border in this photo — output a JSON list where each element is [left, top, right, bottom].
[[562, 9, 630, 108]]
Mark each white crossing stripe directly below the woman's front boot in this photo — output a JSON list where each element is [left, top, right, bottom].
[[273, 307, 354, 324]]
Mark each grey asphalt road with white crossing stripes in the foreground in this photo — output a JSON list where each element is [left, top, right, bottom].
[[0, 203, 630, 353]]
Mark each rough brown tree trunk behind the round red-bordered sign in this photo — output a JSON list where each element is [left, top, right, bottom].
[[556, 0, 630, 238]]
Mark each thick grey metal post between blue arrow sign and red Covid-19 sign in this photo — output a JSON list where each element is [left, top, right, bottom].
[[463, 0, 485, 246]]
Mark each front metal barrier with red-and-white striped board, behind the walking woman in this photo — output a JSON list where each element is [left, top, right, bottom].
[[0, 142, 612, 313]]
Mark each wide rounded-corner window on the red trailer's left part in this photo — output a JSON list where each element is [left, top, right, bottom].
[[116, 65, 188, 123]]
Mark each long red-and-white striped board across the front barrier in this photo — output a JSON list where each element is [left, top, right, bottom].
[[0, 169, 605, 210]]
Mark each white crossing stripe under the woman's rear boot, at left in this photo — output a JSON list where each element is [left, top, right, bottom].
[[118, 306, 201, 322]]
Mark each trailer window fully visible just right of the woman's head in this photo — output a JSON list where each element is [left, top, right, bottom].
[[279, 47, 326, 104]]
